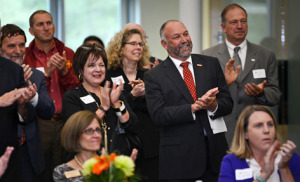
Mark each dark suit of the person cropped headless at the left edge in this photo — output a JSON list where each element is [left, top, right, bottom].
[[0, 56, 35, 181]]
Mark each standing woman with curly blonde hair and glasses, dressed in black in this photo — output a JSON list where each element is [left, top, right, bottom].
[[107, 28, 159, 182]]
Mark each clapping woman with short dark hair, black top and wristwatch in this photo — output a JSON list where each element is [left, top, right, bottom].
[[61, 44, 138, 161]]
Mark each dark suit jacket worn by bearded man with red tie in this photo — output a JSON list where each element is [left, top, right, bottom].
[[144, 54, 233, 179]]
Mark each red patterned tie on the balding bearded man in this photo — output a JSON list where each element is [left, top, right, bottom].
[[180, 62, 197, 101]]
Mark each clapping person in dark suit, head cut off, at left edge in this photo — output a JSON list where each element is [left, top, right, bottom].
[[0, 18, 36, 182]]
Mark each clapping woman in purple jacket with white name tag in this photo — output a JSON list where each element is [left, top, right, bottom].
[[219, 105, 300, 182]]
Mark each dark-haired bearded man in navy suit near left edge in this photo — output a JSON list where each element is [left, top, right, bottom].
[[1, 24, 55, 182]]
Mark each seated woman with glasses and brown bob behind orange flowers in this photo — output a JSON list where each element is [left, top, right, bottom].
[[53, 111, 102, 182]]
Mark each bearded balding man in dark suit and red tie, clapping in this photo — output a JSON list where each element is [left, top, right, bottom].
[[144, 20, 233, 182]]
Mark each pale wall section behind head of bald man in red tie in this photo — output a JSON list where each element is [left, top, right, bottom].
[[140, 0, 202, 60]]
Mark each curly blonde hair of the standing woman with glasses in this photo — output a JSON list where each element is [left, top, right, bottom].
[[107, 28, 150, 70]]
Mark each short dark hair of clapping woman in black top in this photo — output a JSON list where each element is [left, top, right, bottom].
[[73, 44, 107, 82]]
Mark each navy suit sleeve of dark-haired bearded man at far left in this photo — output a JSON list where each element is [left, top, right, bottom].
[[36, 70, 55, 120]]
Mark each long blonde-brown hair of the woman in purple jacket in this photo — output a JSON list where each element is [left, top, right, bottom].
[[228, 105, 281, 159]]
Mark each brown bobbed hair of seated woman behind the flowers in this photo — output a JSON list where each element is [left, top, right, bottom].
[[61, 110, 101, 152]]
